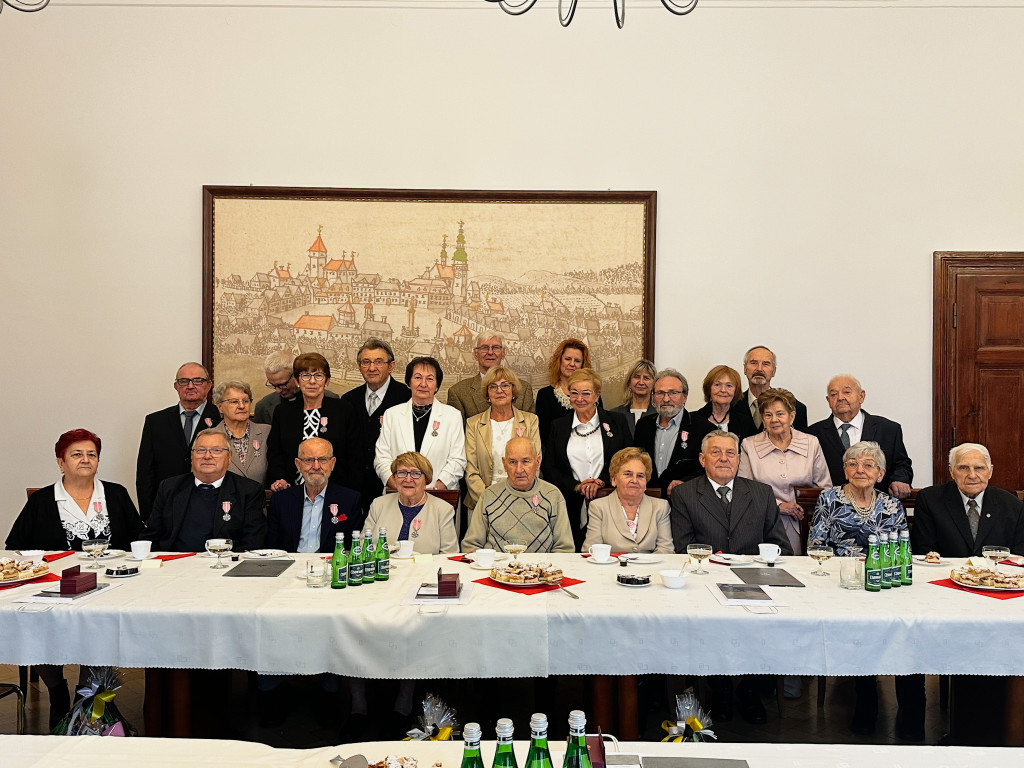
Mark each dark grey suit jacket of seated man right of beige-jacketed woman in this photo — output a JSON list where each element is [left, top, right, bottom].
[[669, 475, 793, 555]]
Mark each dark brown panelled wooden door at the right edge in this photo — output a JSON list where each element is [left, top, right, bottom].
[[933, 252, 1024, 490]]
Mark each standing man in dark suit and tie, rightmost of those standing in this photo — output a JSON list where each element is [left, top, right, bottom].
[[807, 374, 913, 499]]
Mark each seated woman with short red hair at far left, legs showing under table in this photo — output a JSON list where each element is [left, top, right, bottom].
[[6, 429, 142, 730]]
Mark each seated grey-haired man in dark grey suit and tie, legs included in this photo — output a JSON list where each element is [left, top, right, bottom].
[[670, 429, 793, 725]]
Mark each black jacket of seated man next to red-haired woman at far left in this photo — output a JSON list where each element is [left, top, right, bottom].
[[142, 472, 266, 552]]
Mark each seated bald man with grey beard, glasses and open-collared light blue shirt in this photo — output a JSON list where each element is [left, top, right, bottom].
[[266, 437, 362, 552]]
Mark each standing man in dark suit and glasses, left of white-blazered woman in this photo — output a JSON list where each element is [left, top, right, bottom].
[[341, 338, 412, 515]]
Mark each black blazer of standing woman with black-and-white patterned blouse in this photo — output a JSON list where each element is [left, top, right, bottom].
[[266, 397, 352, 487]]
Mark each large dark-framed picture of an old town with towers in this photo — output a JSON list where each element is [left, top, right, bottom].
[[203, 186, 656, 408]]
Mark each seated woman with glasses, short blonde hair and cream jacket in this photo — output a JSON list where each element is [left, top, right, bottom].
[[364, 451, 459, 555]]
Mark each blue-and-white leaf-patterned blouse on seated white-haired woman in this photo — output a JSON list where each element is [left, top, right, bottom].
[[807, 485, 906, 557]]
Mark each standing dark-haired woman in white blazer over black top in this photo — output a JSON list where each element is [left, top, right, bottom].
[[374, 357, 466, 489]]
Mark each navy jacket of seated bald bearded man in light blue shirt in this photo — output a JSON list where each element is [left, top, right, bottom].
[[266, 481, 362, 552]]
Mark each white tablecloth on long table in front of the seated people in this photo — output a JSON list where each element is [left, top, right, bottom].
[[0, 555, 1024, 678]]
